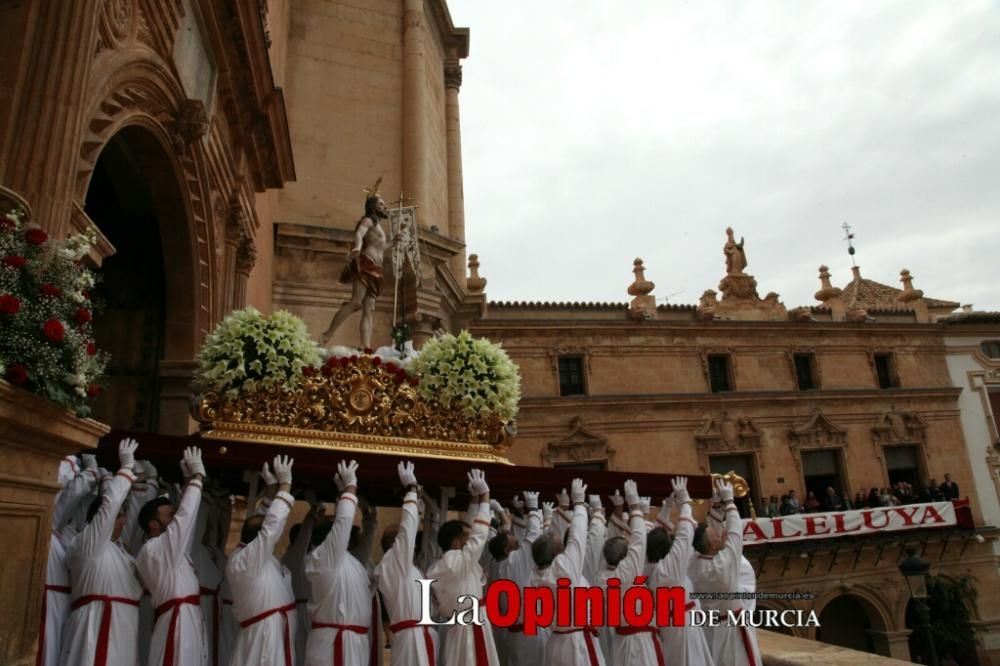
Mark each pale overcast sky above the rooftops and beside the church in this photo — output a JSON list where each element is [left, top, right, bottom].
[[449, 0, 1000, 310]]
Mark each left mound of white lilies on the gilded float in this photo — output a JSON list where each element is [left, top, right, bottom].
[[194, 308, 319, 398]]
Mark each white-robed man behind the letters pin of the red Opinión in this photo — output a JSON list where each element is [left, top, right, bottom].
[[531, 479, 605, 666]]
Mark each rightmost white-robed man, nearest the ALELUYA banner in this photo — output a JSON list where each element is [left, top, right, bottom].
[[689, 480, 763, 666]]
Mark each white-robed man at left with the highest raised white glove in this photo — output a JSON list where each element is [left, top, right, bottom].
[[59, 439, 142, 666]]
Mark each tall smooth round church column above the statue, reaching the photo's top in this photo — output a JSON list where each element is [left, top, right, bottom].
[[402, 0, 433, 227]]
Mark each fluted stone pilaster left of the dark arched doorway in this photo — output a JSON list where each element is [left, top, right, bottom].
[[0, 0, 103, 236]]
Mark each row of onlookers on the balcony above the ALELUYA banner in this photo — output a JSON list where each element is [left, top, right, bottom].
[[757, 474, 959, 518]]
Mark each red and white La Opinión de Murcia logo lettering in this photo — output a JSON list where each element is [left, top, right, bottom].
[[416, 576, 819, 636]]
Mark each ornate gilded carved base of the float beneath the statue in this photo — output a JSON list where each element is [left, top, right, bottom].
[[193, 355, 512, 464]]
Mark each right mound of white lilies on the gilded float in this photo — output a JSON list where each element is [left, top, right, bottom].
[[408, 331, 521, 421]]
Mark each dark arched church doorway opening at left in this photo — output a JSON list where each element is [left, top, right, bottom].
[[84, 126, 190, 432]]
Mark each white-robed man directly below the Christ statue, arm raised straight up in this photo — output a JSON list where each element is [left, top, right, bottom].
[[305, 460, 378, 666]]
